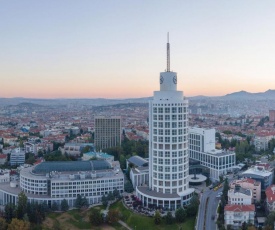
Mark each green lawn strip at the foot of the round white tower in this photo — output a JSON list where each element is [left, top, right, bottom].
[[110, 201, 195, 230]]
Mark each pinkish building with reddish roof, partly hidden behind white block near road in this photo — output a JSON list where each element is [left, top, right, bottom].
[[230, 178, 261, 203]]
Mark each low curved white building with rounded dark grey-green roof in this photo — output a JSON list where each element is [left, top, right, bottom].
[[0, 160, 124, 207]]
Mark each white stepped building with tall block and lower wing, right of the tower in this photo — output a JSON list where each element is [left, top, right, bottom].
[[189, 127, 236, 181]]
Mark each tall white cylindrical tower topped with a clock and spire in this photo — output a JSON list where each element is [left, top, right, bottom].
[[136, 35, 194, 210]]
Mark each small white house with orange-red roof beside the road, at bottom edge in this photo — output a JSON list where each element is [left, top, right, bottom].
[[224, 204, 255, 228]]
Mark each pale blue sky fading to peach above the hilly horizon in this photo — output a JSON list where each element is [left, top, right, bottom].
[[0, 0, 275, 98]]
